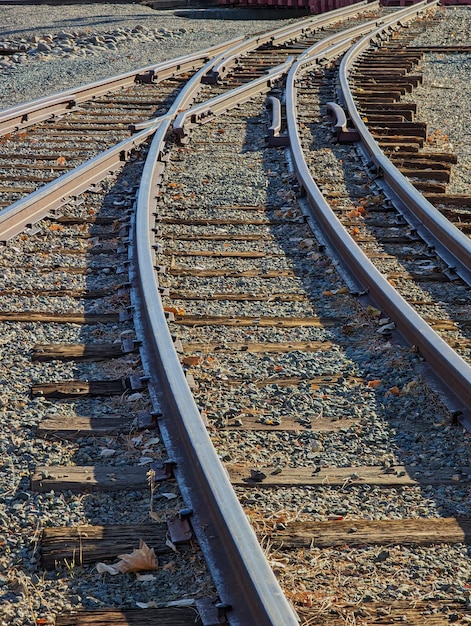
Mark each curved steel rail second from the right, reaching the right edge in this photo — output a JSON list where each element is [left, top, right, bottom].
[[286, 2, 471, 406]]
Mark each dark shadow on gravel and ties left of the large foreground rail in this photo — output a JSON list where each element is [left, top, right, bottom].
[[25, 150, 207, 609]]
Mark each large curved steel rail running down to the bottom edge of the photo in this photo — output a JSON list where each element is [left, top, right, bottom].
[[131, 11, 414, 626]]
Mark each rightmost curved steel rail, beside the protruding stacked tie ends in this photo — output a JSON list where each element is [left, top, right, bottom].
[[339, 0, 471, 272]]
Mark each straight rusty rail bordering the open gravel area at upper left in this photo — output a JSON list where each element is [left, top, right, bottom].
[[0, 36, 244, 135]]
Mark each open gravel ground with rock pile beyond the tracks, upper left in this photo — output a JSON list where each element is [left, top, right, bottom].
[[0, 3, 286, 108]]
